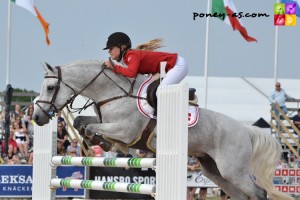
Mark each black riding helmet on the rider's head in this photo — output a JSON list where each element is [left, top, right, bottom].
[[103, 32, 131, 50]]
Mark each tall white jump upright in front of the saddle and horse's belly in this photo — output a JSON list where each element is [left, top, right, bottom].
[[156, 84, 188, 200]]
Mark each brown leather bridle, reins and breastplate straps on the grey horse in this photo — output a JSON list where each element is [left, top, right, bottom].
[[35, 65, 147, 123]]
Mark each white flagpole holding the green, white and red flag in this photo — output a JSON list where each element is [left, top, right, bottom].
[[204, 0, 211, 108]]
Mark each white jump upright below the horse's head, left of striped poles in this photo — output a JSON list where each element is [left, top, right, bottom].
[[32, 118, 57, 200]]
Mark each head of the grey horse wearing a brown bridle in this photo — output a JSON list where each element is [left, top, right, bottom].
[[33, 63, 74, 126]]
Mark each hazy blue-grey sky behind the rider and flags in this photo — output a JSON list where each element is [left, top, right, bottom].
[[0, 0, 300, 92]]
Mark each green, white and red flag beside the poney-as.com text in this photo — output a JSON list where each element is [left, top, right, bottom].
[[212, 0, 257, 42]]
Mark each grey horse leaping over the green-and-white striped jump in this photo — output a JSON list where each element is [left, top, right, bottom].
[[33, 60, 293, 200]]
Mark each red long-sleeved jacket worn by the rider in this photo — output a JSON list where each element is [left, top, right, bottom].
[[115, 50, 177, 78]]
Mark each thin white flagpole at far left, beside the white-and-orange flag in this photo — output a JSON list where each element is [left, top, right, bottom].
[[6, 0, 11, 85]]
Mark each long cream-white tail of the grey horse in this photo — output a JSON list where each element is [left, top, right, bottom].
[[249, 127, 293, 200]]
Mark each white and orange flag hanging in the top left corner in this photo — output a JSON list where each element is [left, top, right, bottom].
[[11, 0, 50, 45]]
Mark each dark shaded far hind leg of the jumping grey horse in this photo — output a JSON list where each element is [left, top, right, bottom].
[[198, 156, 249, 200]]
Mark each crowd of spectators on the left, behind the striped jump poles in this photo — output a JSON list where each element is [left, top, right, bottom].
[[0, 104, 155, 164]]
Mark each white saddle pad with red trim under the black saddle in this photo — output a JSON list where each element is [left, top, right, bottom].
[[137, 75, 199, 127]]
